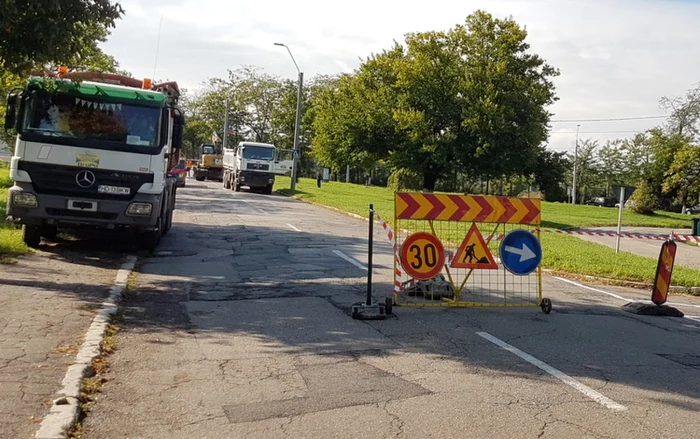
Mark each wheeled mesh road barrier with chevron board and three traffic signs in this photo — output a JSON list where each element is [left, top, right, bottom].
[[392, 192, 551, 313]]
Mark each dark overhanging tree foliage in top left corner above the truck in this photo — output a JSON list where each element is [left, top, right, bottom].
[[0, 0, 124, 75]]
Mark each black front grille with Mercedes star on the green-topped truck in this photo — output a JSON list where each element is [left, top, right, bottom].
[[18, 160, 153, 200]]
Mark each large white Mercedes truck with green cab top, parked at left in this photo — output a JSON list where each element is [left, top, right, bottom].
[[5, 68, 185, 250]]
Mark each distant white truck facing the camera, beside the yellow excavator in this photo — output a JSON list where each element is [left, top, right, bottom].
[[223, 142, 293, 194]]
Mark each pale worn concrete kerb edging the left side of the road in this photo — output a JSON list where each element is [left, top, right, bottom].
[[34, 255, 137, 439]]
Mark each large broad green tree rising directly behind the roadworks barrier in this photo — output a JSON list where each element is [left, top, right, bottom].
[[314, 11, 558, 191]]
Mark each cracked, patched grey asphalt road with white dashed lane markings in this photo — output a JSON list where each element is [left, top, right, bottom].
[[84, 181, 700, 439]]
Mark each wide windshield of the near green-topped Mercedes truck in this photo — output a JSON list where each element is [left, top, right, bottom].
[[22, 93, 161, 148]]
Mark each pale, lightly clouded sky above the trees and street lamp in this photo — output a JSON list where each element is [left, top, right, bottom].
[[102, 0, 700, 155]]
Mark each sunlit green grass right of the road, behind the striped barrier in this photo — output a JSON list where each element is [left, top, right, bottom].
[[275, 177, 700, 287]]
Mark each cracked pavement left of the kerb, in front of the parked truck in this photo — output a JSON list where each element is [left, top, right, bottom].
[[0, 246, 121, 438]]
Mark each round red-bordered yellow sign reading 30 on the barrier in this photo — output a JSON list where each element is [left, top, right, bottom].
[[399, 232, 445, 280]]
